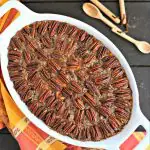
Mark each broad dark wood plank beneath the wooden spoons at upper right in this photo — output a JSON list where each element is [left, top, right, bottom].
[[26, 2, 150, 66]]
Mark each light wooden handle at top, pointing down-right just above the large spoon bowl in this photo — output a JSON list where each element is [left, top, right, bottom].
[[90, 0, 120, 24]]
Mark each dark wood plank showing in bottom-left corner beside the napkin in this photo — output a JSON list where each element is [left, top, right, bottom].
[[0, 134, 20, 150]]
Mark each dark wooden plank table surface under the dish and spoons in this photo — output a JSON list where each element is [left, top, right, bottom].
[[0, 0, 150, 150]]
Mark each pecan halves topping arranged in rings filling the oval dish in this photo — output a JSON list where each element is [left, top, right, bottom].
[[8, 21, 132, 141]]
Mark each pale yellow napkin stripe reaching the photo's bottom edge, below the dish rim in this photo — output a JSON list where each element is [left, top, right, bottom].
[[36, 137, 56, 150]]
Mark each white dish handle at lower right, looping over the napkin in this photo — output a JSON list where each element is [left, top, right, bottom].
[[134, 110, 150, 150]]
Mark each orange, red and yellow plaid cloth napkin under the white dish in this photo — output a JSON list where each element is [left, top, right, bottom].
[[0, 0, 150, 150]]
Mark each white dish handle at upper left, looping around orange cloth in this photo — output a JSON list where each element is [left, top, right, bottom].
[[0, 1, 36, 47]]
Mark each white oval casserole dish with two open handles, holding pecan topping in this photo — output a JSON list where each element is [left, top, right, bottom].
[[0, 1, 150, 150]]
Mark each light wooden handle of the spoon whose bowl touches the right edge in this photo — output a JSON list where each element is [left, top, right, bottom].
[[112, 28, 138, 45]]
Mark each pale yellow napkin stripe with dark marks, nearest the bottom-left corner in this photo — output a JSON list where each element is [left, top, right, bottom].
[[13, 117, 30, 137]]
